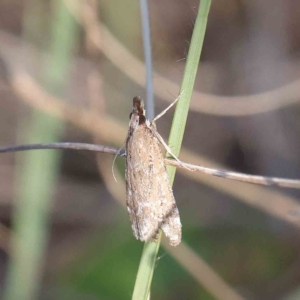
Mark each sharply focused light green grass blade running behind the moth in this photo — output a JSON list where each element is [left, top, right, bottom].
[[132, 0, 211, 300]]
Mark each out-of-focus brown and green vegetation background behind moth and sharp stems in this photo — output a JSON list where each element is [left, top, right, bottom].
[[0, 0, 300, 300]]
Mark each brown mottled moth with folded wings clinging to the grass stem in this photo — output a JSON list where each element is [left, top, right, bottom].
[[125, 97, 181, 246]]
